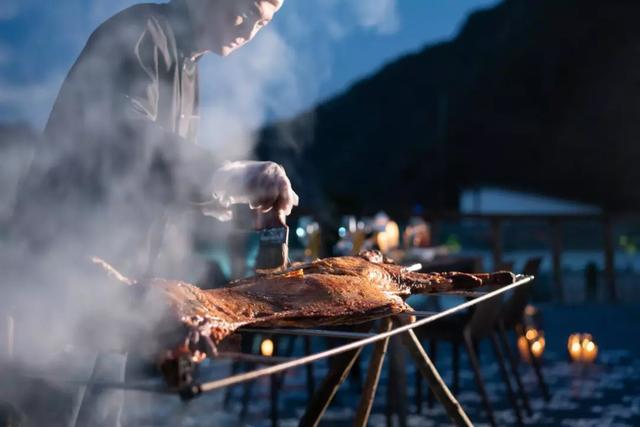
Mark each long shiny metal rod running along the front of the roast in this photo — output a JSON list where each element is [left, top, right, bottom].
[[197, 277, 533, 393]]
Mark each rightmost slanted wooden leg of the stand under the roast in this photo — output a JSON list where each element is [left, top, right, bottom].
[[400, 319, 473, 426]]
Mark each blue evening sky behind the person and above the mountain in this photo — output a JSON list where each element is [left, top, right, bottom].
[[0, 0, 497, 128]]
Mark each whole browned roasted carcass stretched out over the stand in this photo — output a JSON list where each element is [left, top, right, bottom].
[[141, 252, 514, 362]]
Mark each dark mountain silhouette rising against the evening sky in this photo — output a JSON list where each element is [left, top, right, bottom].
[[257, 0, 640, 219]]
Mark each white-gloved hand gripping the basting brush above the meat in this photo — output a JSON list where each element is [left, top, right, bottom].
[[203, 161, 299, 223]]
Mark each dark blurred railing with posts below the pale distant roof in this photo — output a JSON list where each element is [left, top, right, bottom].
[[426, 213, 640, 302]]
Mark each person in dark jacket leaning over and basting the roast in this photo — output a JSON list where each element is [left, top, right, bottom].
[[14, 0, 297, 277]]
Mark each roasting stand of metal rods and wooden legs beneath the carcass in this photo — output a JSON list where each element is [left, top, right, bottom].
[[2, 276, 534, 426]]
